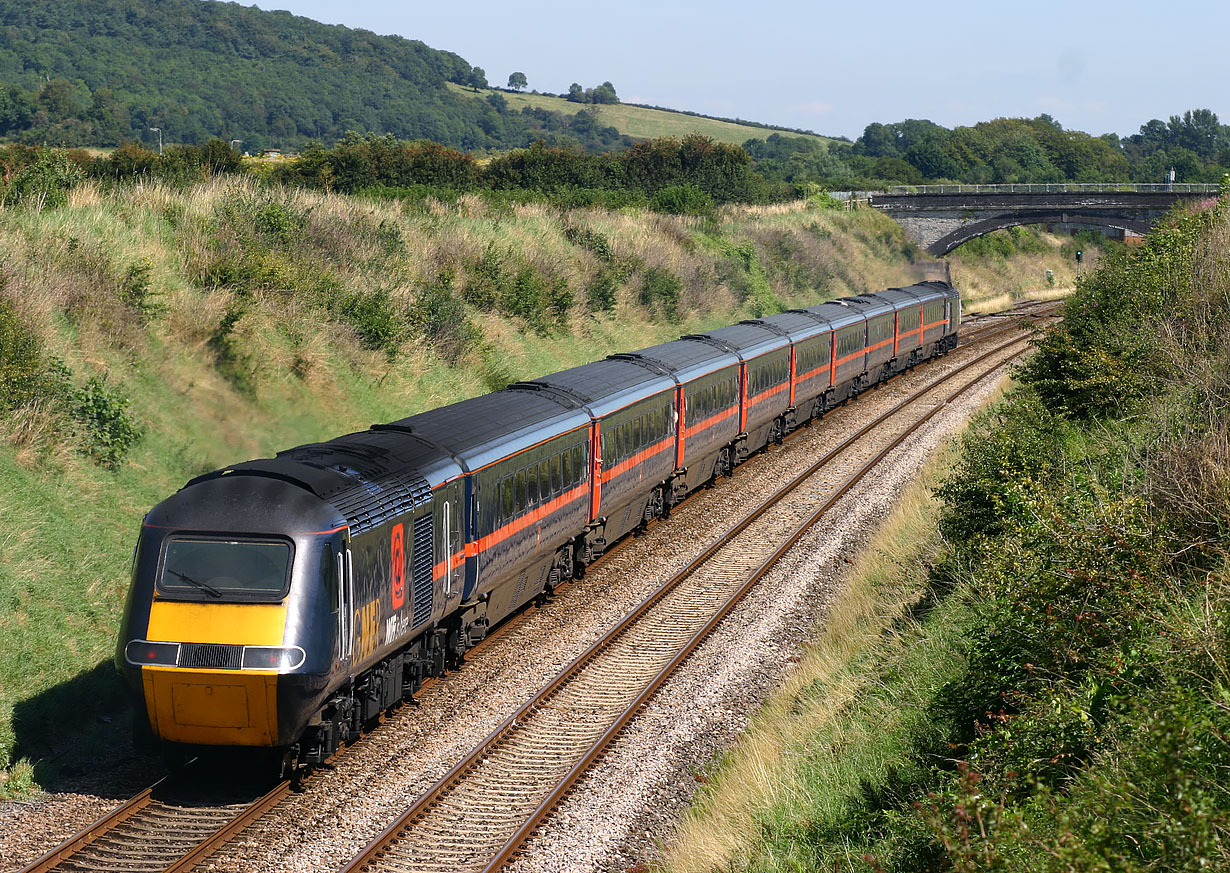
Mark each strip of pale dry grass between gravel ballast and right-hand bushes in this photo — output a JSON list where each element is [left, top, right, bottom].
[[665, 380, 1006, 873]]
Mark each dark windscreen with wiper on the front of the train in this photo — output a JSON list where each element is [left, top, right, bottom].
[[159, 539, 290, 600]]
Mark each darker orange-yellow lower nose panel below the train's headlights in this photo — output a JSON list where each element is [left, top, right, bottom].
[[141, 666, 278, 746]]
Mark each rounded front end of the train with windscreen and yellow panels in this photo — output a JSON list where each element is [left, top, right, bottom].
[[116, 472, 346, 748]]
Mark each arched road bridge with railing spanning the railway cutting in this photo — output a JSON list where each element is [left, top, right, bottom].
[[871, 183, 1218, 257]]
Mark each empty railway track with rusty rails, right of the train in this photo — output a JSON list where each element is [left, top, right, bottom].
[[343, 328, 1043, 873]]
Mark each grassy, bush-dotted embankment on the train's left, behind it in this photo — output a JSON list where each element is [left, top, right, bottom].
[[0, 181, 1077, 796]]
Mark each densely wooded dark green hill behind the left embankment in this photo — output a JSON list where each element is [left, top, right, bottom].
[[0, 0, 516, 149]]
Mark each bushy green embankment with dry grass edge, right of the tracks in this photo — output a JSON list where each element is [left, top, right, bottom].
[[665, 200, 1230, 873]]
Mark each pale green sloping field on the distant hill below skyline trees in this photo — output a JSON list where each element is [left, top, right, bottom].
[[449, 82, 831, 145]]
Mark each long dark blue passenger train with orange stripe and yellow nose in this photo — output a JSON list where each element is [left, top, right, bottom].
[[116, 282, 961, 768]]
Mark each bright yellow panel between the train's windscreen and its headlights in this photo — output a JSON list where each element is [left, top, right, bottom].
[[145, 598, 287, 646]]
